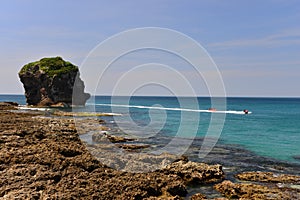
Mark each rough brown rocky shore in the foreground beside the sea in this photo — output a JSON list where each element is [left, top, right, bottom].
[[0, 103, 300, 199]]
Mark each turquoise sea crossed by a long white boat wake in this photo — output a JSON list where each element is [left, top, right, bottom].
[[0, 95, 300, 170]]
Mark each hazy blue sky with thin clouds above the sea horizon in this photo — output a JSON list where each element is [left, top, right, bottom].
[[0, 0, 300, 97]]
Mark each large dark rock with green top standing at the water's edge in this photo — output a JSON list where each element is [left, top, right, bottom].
[[19, 57, 90, 106]]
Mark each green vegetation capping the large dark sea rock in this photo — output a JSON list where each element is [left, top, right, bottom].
[[19, 57, 78, 76]]
